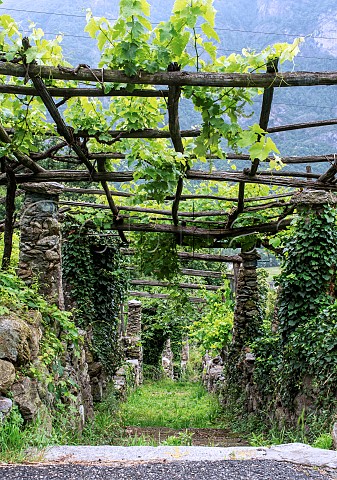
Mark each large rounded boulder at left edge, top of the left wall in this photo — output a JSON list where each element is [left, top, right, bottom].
[[0, 312, 42, 365]]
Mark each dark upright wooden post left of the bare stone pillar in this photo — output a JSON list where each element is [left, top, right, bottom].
[[1, 166, 16, 270]]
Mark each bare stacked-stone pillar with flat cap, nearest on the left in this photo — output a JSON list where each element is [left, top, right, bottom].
[[18, 183, 64, 308]]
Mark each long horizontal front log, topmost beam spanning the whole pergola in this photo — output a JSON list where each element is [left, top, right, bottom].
[[4, 62, 337, 88]]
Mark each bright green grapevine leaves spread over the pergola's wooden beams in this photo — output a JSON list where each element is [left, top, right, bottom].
[[0, 0, 303, 262]]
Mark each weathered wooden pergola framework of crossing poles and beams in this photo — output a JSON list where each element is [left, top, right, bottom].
[[0, 59, 337, 301]]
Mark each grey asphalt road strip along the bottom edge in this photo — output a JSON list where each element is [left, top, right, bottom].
[[0, 460, 337, 480]]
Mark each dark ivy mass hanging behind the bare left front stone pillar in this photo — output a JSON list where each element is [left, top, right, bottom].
[[63, 218, 127, 374]]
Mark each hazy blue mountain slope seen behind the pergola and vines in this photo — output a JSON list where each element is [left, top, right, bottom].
[[0, 0, 337, 162]]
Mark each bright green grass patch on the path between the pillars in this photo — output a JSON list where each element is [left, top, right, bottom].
[[122, 379, 218, 428]]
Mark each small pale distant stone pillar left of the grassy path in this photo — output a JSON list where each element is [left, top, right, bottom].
[[124, 300, 143, 385]]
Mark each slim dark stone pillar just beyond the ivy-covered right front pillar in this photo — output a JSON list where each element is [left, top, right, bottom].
[[232, 249, 260, 352]]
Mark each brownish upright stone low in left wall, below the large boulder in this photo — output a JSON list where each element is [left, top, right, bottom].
[[12, 377, 42, 420]]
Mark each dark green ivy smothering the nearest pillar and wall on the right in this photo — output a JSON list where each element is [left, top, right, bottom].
[[252, 205, 337, 410]]
